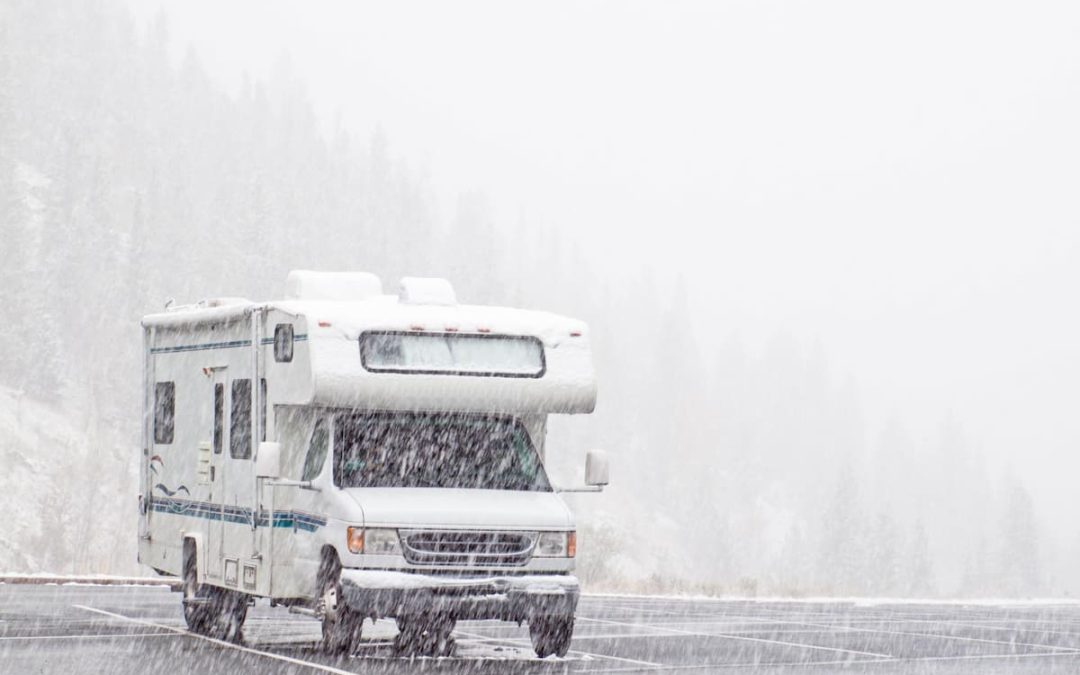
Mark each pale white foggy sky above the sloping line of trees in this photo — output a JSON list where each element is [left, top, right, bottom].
[[132, 0, 1080, 523]]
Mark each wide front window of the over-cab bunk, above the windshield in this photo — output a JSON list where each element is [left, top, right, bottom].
[[360, 330, 545, 377]]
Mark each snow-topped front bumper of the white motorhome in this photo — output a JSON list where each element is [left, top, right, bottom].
[[341, 569, 581, 621]]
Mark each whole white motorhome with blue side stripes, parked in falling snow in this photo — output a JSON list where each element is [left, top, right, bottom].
[[138, 272, 607, 657]]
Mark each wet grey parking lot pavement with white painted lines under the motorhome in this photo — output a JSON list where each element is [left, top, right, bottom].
[[0, 583, 1080, 674]]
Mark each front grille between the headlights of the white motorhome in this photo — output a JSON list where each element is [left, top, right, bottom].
[[401, 530, 537, 567]]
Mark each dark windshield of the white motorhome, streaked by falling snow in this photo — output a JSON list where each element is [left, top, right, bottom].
[[334, 413, 551, 491]]
